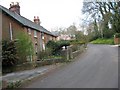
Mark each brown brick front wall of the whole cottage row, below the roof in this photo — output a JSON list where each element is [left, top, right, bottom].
[[0, 13, 55, 59]]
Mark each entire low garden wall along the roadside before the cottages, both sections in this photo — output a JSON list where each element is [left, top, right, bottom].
[[2, 44, 86, 74]]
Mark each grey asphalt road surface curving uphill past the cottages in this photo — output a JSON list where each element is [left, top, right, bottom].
[[26, 44, 118, 88]]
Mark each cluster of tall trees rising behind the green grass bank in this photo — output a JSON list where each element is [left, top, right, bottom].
[[82, 1, 120, 39]]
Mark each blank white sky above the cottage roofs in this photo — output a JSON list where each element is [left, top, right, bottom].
[[0, 0, 83, 30]]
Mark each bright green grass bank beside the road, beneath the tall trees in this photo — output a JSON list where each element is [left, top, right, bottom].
[[90, 38, 114, 45]]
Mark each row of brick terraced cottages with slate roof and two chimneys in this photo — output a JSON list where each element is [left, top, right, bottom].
[[0, 3, 57, 60]]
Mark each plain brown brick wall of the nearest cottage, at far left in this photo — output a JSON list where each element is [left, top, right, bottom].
[[2, 13, 24, 40]]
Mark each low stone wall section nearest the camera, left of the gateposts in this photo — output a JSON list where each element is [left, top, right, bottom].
[[2, 58, 63, 74]]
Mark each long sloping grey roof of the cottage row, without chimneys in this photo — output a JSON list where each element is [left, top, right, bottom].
[[0, 5, 56, 36]]
